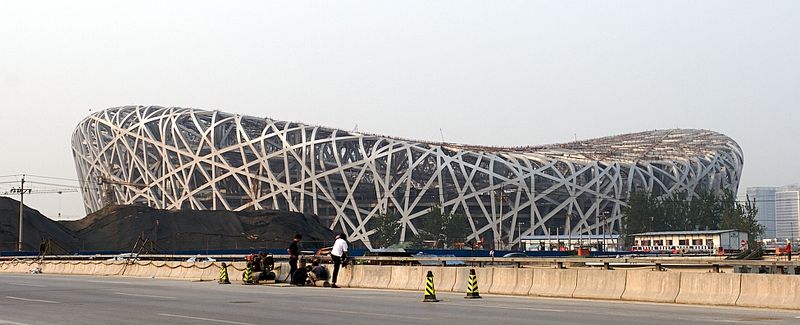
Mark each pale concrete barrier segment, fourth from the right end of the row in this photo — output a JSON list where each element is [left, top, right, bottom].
[[572, 270, 627, 300]]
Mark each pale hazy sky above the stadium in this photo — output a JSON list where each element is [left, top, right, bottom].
[[0, 0, 800, 218]]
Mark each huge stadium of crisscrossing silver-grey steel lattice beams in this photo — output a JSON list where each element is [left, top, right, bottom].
[[72, 106, 743, 245]]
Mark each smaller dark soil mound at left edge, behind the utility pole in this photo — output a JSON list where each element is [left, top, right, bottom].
[[0, 197, 80, 253]]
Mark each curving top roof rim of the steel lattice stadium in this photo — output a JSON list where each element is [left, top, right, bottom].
[[87, 105, 743, 163]]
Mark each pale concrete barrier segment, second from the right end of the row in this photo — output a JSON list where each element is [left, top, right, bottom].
[[675, 273, 741, 306]]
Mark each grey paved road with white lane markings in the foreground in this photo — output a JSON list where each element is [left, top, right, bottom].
[[0, 274, 800, 325]]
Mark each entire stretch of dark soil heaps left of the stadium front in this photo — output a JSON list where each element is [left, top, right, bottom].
[[0, 197, 334, 253]]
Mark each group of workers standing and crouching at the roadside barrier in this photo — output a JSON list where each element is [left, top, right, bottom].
[[287, 234, 348, 288]]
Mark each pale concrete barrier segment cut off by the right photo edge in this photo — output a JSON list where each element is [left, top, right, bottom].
[[736, 274, 800, 309]]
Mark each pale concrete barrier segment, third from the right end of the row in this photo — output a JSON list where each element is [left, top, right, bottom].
[[622, 270, 681, 302]]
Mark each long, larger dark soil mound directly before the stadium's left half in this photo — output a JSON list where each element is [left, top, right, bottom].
[[62, 206, 333, 253]]
